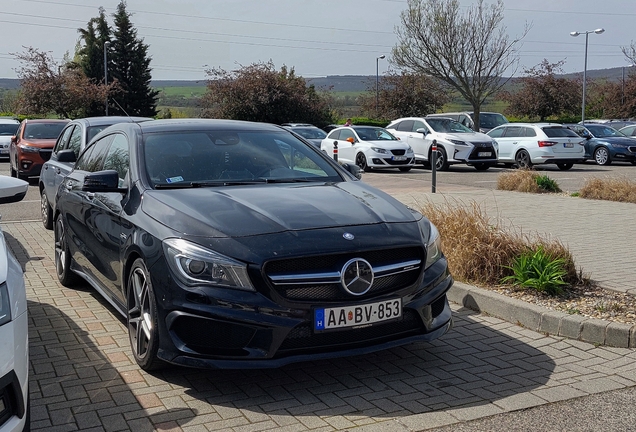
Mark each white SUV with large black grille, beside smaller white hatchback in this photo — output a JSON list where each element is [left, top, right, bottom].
[[386, 117, 497, 171]]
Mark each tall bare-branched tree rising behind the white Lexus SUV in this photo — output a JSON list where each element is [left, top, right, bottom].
[[393, 0, 529, 130]]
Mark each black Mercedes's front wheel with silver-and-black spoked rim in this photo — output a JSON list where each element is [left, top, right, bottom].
[[126, 258, 163, 371]]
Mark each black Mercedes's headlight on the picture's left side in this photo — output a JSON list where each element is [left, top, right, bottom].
[[163, 239, 256, 291]]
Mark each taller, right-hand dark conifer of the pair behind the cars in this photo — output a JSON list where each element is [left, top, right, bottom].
[[108, 1, 159, 117]]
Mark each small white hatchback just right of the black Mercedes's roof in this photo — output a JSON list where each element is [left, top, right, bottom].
[[320, 126, 415, 171]]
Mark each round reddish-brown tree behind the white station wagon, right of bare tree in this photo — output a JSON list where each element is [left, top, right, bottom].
[[502, 59, 581, 121]]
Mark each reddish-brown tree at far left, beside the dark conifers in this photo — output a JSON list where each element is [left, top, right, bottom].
[[13, 47, 112, 118]]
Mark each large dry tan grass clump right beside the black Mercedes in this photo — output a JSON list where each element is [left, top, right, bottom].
[[421, 202, 582, 286]]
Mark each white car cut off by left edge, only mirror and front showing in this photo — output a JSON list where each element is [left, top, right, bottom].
[[0, 176, 30, 432]]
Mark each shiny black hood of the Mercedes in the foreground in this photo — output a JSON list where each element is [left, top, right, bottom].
[[142, 182, 419, 237]]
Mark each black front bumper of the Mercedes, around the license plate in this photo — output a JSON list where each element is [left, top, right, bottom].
[[151, 258, 453, 369]]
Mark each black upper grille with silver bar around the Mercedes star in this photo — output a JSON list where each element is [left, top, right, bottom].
[[264, 247, 424, 302]]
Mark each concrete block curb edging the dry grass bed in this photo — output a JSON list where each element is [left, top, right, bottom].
[[448, 282, 636, 348]]
